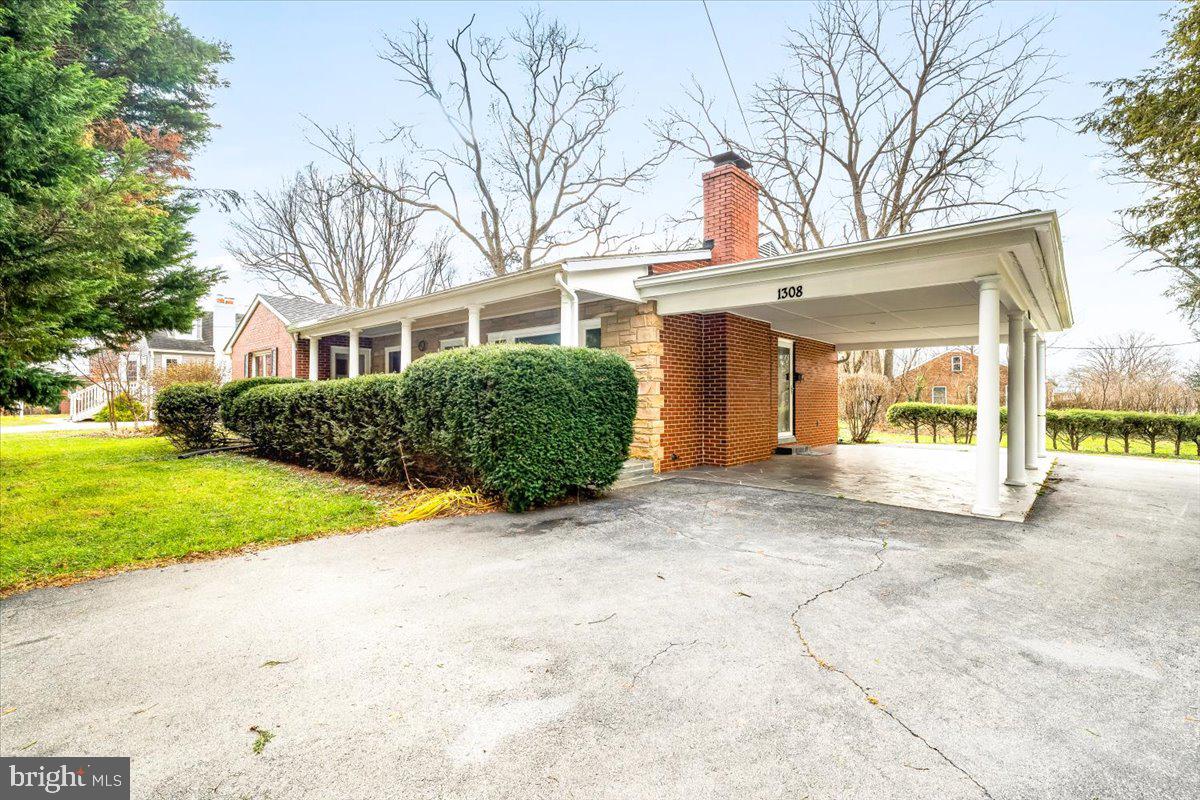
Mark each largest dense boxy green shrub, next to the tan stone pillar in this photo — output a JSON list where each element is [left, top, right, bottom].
[[401, 344, 637, 511]]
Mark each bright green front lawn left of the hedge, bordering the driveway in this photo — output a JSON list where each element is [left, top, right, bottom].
[[0, 433, 385, 593]]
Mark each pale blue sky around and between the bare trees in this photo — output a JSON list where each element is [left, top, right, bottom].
[[168, 1, 1200, 374]]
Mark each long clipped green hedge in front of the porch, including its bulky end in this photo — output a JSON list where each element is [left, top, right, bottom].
[[205, 344, 637, 511]]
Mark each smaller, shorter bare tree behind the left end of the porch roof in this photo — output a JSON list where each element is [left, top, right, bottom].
[[226, 164, 450, 308]]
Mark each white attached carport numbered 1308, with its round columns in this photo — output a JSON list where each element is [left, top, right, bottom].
[[636, 211, 1072, 517]]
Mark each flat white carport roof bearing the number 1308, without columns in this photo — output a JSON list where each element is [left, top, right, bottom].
[[635, 211, 1073, 350]]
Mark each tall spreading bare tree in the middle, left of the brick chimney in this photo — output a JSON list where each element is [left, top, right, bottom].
[[320, 13, 666, 275]]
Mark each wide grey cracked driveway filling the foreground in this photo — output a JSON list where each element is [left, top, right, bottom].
[[0, 456, 1200, 800]]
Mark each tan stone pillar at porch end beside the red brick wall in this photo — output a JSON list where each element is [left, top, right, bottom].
[[600, 302, 664, 473]]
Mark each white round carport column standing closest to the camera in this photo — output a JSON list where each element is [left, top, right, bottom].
[[971, 275, 1000, 517]]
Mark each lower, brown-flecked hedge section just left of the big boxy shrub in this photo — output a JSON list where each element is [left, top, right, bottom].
[[230, 375, 406, 480]]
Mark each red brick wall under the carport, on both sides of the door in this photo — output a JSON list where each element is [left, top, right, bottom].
[[661, 313, 838, 471]]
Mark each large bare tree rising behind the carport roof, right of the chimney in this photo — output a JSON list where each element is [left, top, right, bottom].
[[656, 0, 1055, 377]]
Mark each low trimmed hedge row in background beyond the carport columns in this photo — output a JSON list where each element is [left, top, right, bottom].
[[888, 403, 1200, 456]]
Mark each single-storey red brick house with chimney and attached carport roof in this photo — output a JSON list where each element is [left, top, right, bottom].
[[226, 152, 1072, 507]]
